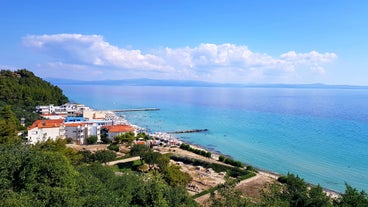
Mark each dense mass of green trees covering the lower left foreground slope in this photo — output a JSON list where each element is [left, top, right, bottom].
[[0, 140, 197, 207]]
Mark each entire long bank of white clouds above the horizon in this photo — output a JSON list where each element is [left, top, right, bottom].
[[23, 34, 337, 82]]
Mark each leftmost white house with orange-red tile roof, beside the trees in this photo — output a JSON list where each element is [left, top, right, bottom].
[[27, 119, 65, 144]]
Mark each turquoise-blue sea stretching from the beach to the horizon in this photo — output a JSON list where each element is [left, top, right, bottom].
[[60, 85, 368, 192]]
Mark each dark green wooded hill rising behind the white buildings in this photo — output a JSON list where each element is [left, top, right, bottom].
[[0, 69, 69, 124]]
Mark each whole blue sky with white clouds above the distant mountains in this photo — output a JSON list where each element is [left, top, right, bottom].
[[0, 0, 368, 85]]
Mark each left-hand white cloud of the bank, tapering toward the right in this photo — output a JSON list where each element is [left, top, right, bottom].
[[23, 34, 171, 70]]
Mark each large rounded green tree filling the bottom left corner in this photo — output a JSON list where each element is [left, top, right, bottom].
[[0, 144, 79, 206]]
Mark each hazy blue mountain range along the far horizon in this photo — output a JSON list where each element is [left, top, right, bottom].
[[44, 78, 368, 89]]
